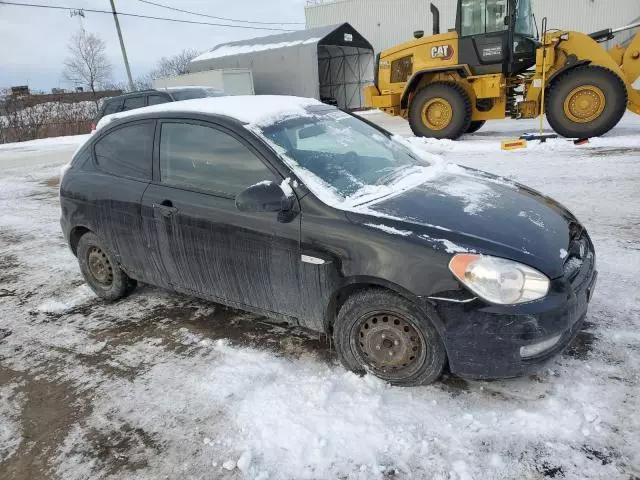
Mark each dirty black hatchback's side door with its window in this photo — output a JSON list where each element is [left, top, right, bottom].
[[143, 120, 300, 316]]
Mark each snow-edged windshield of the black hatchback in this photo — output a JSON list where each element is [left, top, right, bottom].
[[260, 109, 430, 204]]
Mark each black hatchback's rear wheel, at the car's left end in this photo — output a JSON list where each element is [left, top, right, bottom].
[[77, 232, 136, 301]]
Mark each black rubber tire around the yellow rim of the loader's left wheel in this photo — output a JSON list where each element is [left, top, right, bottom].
[[409, 82, 471, 140]]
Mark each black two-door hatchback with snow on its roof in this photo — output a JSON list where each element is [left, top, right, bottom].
[[60, 96, 596, 385]]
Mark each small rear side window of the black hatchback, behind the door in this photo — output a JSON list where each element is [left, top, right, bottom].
[[94, 121, 155, 180]]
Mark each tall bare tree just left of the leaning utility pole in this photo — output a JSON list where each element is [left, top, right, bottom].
[[62, 29, 113, 100]]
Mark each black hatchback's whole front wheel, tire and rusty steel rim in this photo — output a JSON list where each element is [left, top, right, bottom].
[[333, 289, 447, 387]]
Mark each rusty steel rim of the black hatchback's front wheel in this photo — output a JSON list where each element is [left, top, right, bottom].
[[351, 311, 426, 380]]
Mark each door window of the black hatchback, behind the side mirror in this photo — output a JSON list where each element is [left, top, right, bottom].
[[160, 123, 277, 196]]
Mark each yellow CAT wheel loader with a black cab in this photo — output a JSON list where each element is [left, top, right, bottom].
[[364, 0, 640, 139]]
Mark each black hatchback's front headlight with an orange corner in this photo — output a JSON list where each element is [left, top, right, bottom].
[[449, 253, 549, 305]]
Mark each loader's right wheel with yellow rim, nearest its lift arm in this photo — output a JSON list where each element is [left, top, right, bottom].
[[545, 65, 627, 138]]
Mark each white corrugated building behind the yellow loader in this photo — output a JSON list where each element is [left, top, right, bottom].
[[305, 0, 640, 52]]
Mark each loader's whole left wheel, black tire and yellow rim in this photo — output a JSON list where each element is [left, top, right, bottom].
[[409, 82, 471, 140]]
